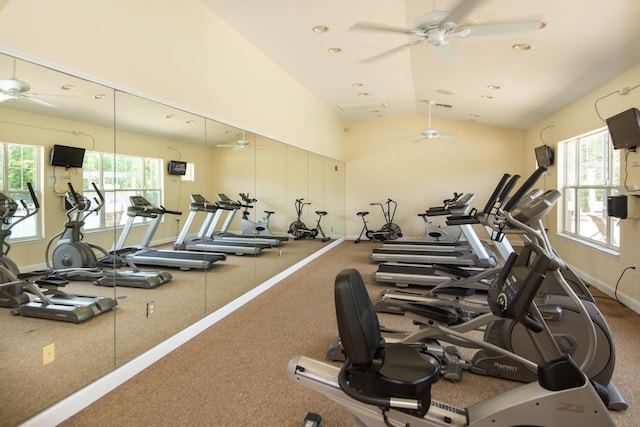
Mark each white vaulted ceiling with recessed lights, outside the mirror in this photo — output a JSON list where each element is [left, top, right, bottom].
[[202, 0, 640, 129]]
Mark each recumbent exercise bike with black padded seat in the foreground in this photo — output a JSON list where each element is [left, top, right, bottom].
[[287, 177, 615, 427]]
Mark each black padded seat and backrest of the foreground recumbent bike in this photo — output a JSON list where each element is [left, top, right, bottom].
[[334, 269, 440, 416]]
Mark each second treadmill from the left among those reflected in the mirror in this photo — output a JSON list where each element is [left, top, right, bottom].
[[173, 194, 271, 255]]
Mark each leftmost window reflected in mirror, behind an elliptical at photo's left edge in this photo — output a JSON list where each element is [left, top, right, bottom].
[[0, 144, 42, 240]]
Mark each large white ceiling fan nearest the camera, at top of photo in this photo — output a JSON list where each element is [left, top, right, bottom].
[[351, 0, 545, 63]]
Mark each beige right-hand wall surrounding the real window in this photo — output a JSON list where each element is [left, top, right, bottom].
[[525, 66, 640, 311]]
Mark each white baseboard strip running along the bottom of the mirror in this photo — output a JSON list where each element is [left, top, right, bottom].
[[21, 237, 345, 427]]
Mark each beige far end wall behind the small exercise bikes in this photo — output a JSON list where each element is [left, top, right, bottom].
[[346, 116, 524, 238]]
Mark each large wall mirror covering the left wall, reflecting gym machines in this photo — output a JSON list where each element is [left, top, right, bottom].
[[0, 54, 345, 425]]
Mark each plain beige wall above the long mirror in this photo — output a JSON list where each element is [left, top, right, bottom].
[[0, 0, 344, 159]]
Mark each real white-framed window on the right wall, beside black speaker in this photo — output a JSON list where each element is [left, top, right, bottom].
[[558, 127, 620, 250]]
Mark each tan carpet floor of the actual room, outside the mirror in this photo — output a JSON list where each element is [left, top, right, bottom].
[[61, 242, 640, 427]]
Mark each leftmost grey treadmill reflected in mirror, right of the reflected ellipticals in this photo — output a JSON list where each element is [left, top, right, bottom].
[[112, 196, 227, 270]]
